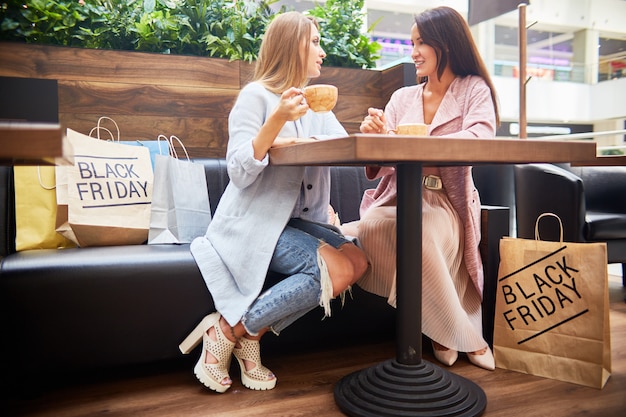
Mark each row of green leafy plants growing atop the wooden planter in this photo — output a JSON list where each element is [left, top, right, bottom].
[[0, 0, 380, 67]]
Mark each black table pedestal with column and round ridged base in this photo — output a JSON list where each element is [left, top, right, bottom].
[[335, 163, 487, 417]]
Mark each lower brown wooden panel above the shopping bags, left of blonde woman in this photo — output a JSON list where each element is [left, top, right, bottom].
[[53, 81, 233, 157]]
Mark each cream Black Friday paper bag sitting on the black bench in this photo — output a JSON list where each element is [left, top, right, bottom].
[[57, 129, 153, 247]]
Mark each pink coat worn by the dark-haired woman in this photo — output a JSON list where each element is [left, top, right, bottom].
[[360, 75, 496, 295]]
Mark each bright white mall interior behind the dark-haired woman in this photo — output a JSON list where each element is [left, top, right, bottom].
[[276, 0, 626, 151]]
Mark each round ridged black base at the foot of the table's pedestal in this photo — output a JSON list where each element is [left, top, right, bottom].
[[335, 359, 487, 417]]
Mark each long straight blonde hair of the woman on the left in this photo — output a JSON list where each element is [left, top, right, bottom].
[[253, 12, 319, 94]]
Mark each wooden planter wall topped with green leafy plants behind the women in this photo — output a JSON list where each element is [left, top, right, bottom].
[[0, 0, 388, 157]]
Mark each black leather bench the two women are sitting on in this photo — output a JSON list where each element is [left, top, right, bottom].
[[0, 159, 508, 382]]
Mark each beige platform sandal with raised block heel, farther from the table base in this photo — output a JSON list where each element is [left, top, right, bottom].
[[178, 313, 235, 392]]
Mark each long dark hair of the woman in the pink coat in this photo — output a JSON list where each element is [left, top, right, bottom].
[[415, 6, 500, 125]]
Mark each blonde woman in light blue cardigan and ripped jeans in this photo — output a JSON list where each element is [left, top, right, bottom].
[[180, 12, 367, 392]]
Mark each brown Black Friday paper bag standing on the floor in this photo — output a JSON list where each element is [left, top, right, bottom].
[[493, 213, 611, 388]]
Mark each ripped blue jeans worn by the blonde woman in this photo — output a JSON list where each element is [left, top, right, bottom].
[[241, 219, 349, 336]]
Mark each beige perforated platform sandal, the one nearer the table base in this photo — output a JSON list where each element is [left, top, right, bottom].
[[233, 337, 276, 390]]
